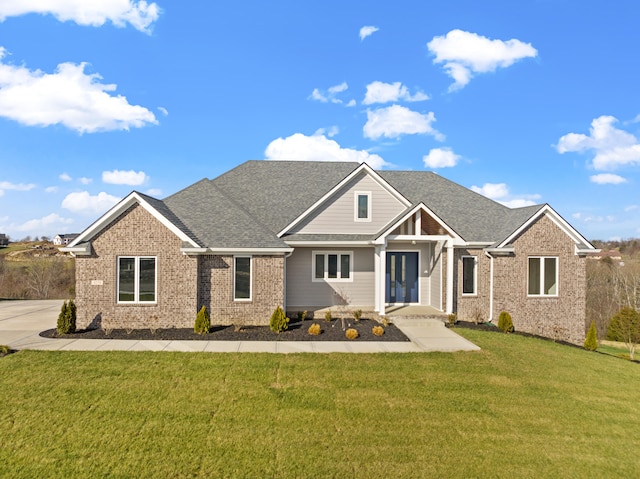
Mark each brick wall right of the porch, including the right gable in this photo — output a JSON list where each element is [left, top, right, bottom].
[[455, 216, 586, 345]]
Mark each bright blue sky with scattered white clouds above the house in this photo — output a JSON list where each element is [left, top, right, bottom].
[[0, 0, 640, 239]]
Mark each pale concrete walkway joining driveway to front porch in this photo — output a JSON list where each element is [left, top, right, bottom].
[[0, 300, 480, 353]]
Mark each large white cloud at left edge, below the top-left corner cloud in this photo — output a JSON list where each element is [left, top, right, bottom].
[[0, 47, 158, 133]]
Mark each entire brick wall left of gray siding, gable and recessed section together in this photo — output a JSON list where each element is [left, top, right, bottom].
[[76, 205, 284, 329]]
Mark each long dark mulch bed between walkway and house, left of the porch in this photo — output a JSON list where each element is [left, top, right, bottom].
[[40, 319, 409, 342]]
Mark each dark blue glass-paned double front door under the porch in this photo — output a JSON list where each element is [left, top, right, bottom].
[[385, 252, 418, 303]]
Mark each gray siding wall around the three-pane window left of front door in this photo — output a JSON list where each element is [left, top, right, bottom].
[[286, 247, 375, 311]]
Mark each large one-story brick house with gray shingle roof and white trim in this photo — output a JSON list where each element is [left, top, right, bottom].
[[63, 161, 595, 344]]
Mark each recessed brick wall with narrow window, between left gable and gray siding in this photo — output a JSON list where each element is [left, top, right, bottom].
[[198, 255, 284, 325]]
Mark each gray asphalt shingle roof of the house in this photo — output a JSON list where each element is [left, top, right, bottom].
[[156, 161, 556, 248]]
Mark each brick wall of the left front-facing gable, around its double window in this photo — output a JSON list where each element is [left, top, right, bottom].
[[76, 205, 198, 329]]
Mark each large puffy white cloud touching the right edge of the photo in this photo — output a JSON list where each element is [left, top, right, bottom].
[[556, 116, 640, 171]]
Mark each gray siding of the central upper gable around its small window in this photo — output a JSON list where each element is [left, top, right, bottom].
[[291, 173, 406, 234]]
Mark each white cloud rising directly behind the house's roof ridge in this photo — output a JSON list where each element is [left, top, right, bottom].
[[265, 133, 390, 168]]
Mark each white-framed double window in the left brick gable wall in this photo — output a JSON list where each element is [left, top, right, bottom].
[[118, 256, 157, 303]]
